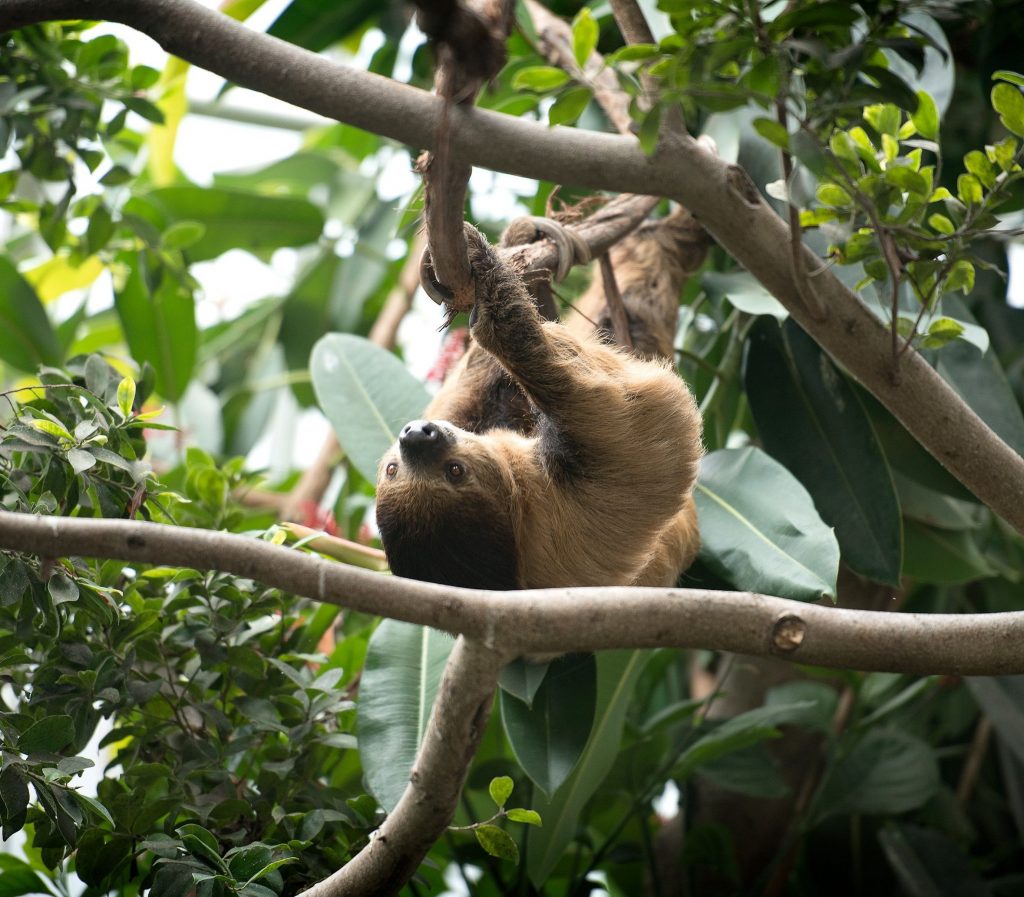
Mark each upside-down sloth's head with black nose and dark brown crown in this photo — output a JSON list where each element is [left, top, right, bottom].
[[377, 421, 518, 589]]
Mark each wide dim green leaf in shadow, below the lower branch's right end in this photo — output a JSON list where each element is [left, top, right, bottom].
[[814, 728, 941, 822]]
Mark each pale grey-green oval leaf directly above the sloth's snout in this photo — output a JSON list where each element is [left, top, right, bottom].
[[309, 333, 429, 482]]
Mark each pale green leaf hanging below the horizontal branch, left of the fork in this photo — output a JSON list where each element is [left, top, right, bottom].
[[358, 620, 455, 812]]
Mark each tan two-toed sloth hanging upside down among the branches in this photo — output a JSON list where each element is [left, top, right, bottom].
[[377, 216, 703, 590]]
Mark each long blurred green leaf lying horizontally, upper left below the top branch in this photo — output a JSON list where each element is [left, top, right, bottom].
[[125, 186, 324, 262]]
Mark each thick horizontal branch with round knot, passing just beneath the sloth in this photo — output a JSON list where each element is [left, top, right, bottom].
[[6, 511, 1024, 676]]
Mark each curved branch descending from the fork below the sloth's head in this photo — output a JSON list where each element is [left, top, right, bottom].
[[304, 638, 511, 897]]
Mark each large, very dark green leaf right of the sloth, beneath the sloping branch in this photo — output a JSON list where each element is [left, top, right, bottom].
[[743, 318, 902, 586]]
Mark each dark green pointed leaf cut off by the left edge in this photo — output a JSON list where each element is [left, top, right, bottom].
[[0, 256, 61, 374]]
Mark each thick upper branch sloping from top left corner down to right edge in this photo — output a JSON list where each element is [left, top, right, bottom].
[[0, 0, 1024, 532]]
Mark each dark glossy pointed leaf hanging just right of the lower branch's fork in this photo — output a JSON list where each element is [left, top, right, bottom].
[[501, 653, 597, 795]]
